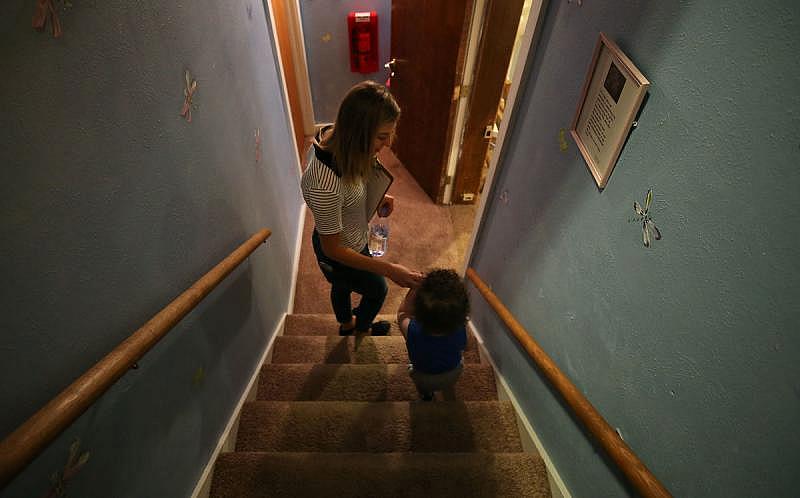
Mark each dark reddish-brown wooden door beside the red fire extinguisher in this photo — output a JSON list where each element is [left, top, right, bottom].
[[390, 0, 472, 202]]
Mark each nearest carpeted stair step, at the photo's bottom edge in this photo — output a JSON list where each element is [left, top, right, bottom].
[[210, 452, 550, 498]]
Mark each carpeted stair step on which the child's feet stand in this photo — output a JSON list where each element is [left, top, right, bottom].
[[257, 363, 497, 401]]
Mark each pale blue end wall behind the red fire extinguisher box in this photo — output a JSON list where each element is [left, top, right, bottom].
[[300, 0, 392, 123]]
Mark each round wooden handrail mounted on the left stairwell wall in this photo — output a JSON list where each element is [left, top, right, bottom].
[[0, 229, 271, 489]]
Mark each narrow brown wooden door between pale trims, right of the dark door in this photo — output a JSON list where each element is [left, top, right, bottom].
[[452, 0, 524, 204]]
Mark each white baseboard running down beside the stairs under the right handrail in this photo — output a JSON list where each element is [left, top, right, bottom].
[[467, 322, 572, 498]]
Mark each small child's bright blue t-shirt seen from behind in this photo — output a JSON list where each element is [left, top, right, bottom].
[[406, 319, 467, 374]]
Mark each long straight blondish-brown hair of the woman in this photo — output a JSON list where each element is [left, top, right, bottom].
[[323, 81, 400, 182]]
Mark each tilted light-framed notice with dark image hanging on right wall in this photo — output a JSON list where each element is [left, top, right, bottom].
[[570, 33, 650, 189]]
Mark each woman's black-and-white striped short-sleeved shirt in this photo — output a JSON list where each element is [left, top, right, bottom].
[[300, 144, 368, 252]]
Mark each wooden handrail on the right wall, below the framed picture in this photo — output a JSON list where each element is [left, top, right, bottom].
[[466, 268, 672, 498]]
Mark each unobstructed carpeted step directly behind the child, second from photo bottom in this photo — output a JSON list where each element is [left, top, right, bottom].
[[236, 401, 522, 453]]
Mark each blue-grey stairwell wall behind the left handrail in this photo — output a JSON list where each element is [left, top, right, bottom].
[[0, 0, 302, 498]]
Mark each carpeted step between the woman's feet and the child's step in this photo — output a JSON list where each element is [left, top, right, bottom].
[[272, 335, 480, 365]]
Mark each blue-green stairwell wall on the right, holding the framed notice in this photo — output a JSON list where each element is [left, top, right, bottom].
[[472, 0, 800, 498]]
